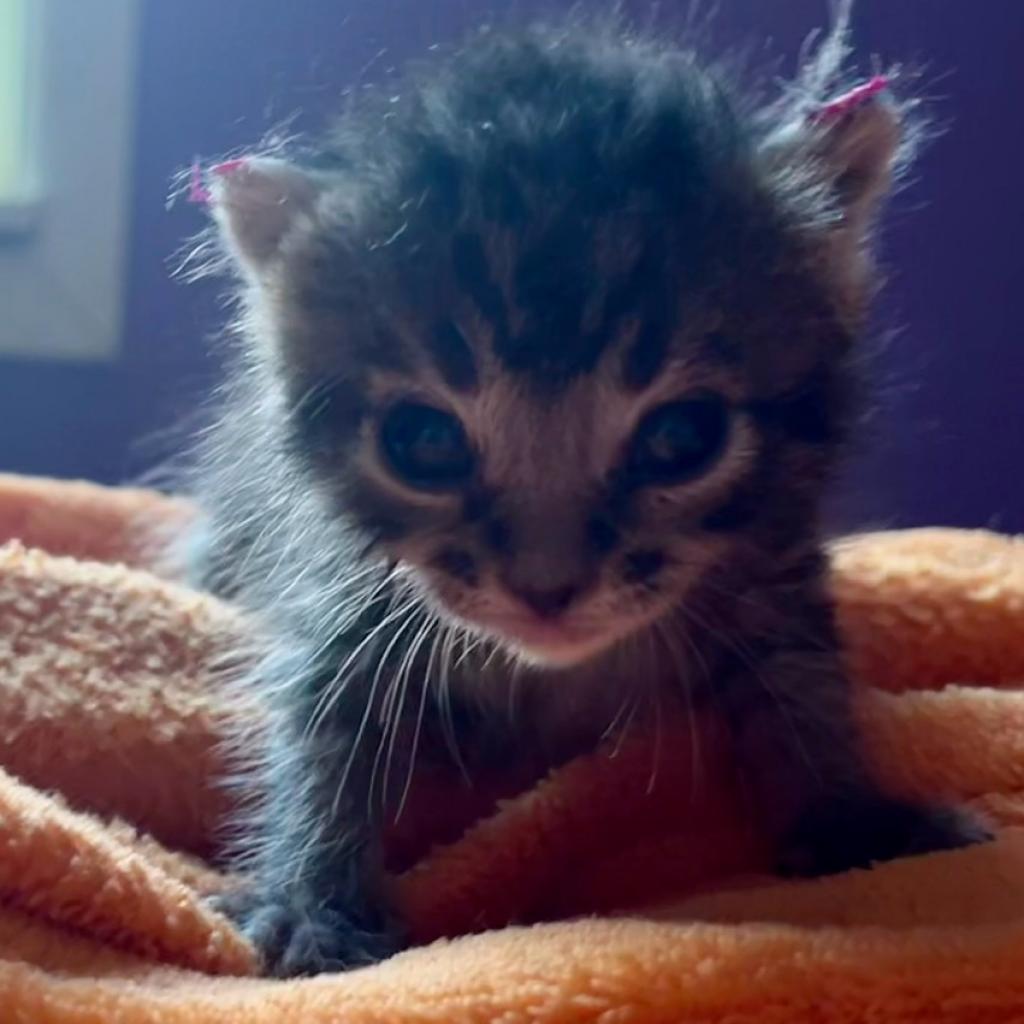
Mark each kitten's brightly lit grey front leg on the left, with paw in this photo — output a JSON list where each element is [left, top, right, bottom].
[[218, 655, 401, 977]]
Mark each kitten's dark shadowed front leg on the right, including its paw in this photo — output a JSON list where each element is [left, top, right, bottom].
[[724, 626, 989, 877]]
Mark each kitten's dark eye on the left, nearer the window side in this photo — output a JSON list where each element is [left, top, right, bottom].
[[380, 402, 473, 489]]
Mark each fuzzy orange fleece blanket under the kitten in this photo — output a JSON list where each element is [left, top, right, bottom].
[[0, 468, 1024, 1024]]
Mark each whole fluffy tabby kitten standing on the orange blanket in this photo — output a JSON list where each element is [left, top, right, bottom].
[[186, 19, 984, 975]]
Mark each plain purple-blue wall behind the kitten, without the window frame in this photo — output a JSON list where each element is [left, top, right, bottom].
[[0, 0, 1024, 529]]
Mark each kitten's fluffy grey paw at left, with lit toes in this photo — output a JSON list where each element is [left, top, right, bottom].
[[214, 893, 401, 978]]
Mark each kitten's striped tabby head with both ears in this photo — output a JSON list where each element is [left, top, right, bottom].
[[203, 24, 900, 664]]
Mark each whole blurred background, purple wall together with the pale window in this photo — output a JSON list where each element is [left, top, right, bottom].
[[0, 0, 1024, 530]]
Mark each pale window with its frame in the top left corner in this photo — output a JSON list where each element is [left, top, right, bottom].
[[0, 0, 138, 360]]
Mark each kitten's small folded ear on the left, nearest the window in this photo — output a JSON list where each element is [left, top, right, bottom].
[[210, 157, 319, 278]]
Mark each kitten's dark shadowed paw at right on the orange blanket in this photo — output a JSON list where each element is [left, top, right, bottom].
[[777, 794, 992, 878]]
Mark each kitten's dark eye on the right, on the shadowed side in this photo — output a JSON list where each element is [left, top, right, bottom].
[[628, 394, 729, 483]]
